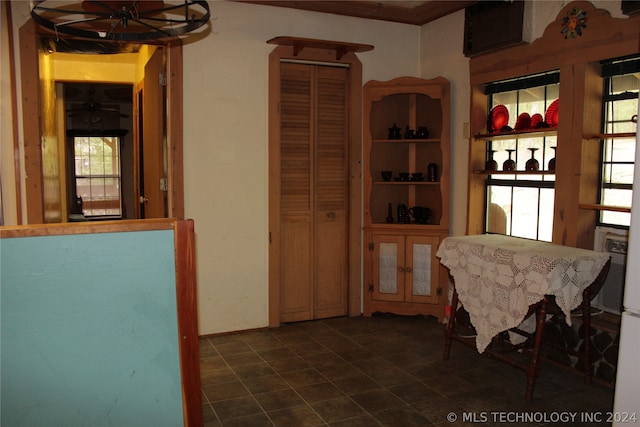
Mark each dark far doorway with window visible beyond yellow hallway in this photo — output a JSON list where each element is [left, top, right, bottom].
[[63, 83, 133, 221]]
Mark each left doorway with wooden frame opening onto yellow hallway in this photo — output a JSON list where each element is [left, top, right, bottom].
[[20, 21, 184, 224]]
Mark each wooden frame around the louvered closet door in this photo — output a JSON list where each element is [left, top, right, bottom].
[[269, 46, 362, 327]]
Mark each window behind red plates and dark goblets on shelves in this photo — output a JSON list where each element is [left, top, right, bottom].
[[485, 71, 559, 241]]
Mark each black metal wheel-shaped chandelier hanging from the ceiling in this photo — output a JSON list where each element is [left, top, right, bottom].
[[31, 0, 210, 42]]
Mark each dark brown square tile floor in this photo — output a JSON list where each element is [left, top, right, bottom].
[[200, 315, 613, 427]]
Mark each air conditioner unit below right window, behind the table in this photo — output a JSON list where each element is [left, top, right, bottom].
[[591, 227, 628, 314]]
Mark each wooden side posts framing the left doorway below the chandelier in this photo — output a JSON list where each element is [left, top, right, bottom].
[[16, 19, 184, 224]]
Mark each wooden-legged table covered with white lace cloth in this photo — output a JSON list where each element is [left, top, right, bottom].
[[437, 234, 610, 401]]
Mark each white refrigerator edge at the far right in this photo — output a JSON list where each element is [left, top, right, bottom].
[[612, 105, 640, 426]]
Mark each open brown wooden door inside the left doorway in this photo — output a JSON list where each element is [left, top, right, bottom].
[[139, 47, 167, 218]]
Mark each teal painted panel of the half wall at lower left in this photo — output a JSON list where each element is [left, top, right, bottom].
[[0, 230, 183, 427]]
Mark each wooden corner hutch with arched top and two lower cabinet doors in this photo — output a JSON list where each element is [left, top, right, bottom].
[[363, 77, 451, 319]]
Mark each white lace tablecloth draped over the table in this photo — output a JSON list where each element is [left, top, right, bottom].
[[437, 234, 609, 353]]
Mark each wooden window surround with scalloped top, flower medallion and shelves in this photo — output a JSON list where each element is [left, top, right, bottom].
[[467, 1, 640, 249]]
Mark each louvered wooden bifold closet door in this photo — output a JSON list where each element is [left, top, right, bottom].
[[280, 63, 349, 322]]
